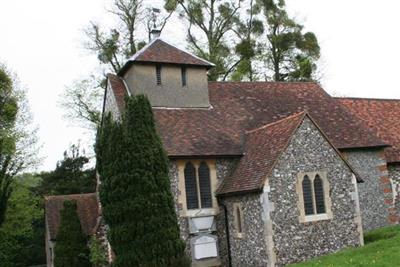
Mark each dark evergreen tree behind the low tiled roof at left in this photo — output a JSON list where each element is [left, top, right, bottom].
[[37, 145, 96, 195]]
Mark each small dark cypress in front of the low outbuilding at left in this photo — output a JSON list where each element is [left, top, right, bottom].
[[54, 200, 91, 267]]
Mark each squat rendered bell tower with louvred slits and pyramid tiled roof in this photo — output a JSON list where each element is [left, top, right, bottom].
[[118, 38, 214, 108]]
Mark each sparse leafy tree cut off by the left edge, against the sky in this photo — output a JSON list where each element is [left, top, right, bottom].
[[0, 64, 38, 226]]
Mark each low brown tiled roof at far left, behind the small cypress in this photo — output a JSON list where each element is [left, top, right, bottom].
[[45, 193, 99, 240]]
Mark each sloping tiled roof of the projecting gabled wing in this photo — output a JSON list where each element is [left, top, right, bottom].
[[217, 112, 306, 195]]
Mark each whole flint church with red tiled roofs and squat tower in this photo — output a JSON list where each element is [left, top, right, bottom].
[[46, 38, 400, 267]]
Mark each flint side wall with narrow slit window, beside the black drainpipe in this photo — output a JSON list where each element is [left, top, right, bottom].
[[222, 194, 268, 267]]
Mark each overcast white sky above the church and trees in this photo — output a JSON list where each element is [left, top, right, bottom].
[[0, 0, 400, 170]]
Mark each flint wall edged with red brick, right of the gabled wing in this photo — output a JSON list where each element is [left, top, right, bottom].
[[343, 149, 393, 231]]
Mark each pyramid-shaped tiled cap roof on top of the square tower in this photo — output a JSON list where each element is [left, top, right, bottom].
[[119, 38, 214, 75]]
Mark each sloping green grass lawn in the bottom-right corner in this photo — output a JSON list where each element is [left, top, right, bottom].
[[290, 225, 400, 267]]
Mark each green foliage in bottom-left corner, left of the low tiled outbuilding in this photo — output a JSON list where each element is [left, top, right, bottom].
[[0, 174, 46, 267]]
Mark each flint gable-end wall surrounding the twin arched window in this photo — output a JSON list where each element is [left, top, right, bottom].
[[269, 118, 362, 266]]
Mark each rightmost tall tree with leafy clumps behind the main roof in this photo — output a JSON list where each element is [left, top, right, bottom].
[[258, 0, 320, 81]]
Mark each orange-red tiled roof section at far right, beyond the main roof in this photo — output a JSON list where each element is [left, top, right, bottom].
[[337, 98, 400, 163]]
